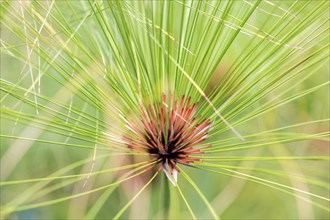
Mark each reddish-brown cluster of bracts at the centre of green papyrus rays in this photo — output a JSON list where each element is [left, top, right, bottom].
[[125, 95, 211, 178]]
